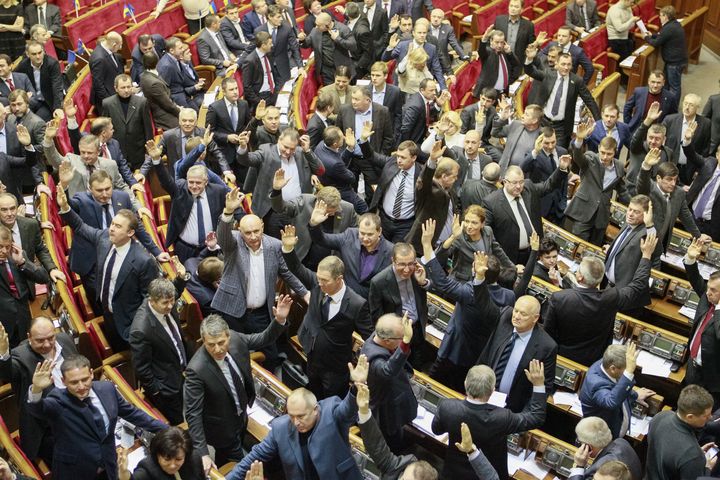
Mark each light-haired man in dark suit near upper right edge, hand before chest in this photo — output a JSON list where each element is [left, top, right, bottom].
[[662, 93, 710, 185]]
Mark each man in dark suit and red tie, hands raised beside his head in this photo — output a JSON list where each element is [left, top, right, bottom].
[[473, 25, 520, 98]]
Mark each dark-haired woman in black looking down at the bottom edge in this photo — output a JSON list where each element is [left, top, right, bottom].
[[118, 427, 205, 480]]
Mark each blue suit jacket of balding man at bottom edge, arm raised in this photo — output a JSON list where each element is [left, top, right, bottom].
[[226, 393, 363, 480]]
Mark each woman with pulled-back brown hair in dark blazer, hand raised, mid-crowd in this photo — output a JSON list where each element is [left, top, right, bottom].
[[435, 205, 514, 282]]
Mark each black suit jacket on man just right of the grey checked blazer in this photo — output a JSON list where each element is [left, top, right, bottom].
[[283, 249, 373, 379]]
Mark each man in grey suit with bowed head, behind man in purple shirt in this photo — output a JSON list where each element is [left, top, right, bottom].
[[270, 168, 357, 271]]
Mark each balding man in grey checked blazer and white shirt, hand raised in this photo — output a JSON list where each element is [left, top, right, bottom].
[[212, 188, 310, 371]]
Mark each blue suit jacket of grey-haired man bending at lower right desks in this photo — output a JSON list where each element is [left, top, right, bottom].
[[579, 360, 637, 438]]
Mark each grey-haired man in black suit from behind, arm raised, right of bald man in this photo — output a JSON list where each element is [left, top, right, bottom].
[[545, 233, 657, 365]]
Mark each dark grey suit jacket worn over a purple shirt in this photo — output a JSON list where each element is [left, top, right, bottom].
[[310, 225, 393, 298]]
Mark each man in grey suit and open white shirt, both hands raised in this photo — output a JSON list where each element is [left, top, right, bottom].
[[236, 128, 325, 238]]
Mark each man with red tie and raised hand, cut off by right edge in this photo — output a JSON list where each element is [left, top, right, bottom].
[[683, 239, 720, 405]]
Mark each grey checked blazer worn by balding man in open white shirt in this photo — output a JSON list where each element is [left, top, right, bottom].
[[212, 217, 307, 318]]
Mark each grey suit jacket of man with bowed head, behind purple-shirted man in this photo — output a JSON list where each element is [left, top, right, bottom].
[[270, 190, 357, 260]]
